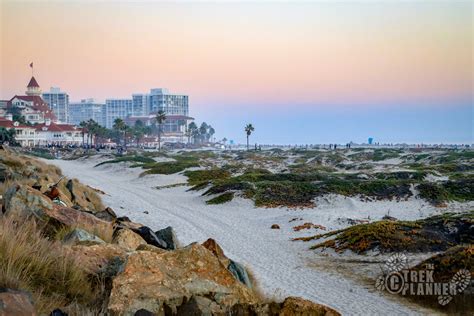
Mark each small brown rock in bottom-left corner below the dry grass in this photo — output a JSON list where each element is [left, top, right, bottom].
[[0, 288, 37, 316]]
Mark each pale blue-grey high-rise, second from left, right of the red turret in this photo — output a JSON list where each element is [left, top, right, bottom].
[[69, 99, 106, 126]]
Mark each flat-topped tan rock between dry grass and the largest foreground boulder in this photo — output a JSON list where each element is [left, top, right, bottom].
[[65, 243, 127, 274]]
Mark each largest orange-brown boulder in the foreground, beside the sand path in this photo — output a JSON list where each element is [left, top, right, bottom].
[[108, 243, 256, 315]]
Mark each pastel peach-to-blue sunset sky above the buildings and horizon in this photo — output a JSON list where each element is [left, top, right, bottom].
[[0, 0, 474, 144]]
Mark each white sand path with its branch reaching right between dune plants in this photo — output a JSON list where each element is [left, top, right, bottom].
[[47, 159, 470, 315]]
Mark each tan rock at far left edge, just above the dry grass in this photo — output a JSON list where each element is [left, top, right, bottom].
[[3, 185, 54, 220]]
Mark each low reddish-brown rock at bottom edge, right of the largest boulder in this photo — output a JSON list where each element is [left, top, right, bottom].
[[279, 297, 341, 316]]
